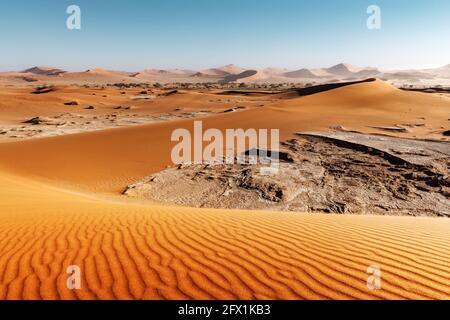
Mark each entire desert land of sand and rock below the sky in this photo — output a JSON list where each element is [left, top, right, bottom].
[[0, 64, 450, 299]]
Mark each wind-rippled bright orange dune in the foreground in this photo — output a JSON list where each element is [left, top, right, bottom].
[[0, 173, 450, 299]]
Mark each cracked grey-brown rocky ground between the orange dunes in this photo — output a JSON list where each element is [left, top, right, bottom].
[[124, 133, 450, 217]]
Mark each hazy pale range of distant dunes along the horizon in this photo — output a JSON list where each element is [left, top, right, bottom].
[[0, 63, 450, 86]]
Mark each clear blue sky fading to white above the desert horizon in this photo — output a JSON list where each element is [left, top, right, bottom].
[[0, 0, 450, 71]]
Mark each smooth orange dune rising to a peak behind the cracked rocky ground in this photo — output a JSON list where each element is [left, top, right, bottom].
[[0, 81, 450, 193]]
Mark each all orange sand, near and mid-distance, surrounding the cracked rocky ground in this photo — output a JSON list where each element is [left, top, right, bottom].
[[0, 75, 450, 299]]
